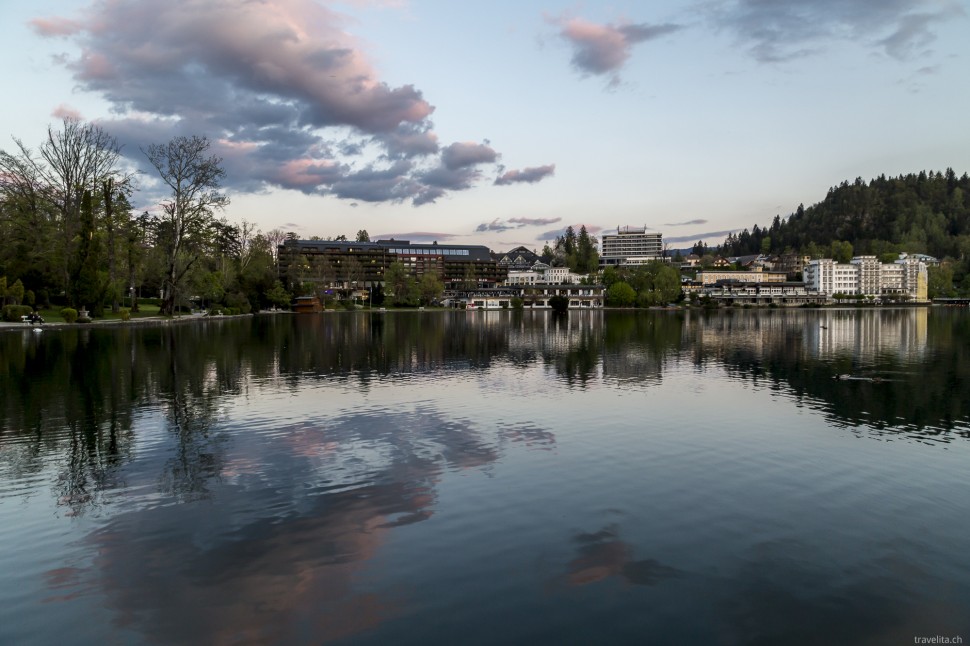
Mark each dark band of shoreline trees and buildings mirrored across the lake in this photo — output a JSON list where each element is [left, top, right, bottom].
[[0, 308, 970, 514]]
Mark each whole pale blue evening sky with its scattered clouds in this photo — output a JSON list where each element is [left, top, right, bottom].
[[0, 0, 970, 251]]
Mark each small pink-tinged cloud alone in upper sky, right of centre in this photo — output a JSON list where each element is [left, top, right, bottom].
[[552, 18, 682, 85]]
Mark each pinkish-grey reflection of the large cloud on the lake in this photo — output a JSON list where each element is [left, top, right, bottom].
[[61, 407, 555, 643]]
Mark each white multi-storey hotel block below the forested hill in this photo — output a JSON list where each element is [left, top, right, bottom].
[[803, 256, 927, 303]]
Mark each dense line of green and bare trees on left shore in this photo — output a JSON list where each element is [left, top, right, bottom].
[[0, 118, 290, 316]]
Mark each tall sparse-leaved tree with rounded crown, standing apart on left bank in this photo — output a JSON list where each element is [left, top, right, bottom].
[[142, 135, 229, 315]]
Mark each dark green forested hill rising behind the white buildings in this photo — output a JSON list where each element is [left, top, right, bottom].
[[721, 168, 970, 261]]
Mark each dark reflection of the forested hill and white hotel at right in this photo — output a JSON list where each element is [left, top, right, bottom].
[[690, 309, 970, 437]]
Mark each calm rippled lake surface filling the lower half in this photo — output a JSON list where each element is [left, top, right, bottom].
[[0, 308, 970, 645]]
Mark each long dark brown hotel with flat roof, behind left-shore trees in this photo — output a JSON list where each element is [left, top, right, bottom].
[[279, 240, 507, 289]]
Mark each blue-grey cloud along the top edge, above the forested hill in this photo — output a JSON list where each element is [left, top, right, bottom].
[[707, 0, 965, 63]]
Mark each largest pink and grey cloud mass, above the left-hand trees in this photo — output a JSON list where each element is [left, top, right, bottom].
[[32, 0, 528, 205]]
